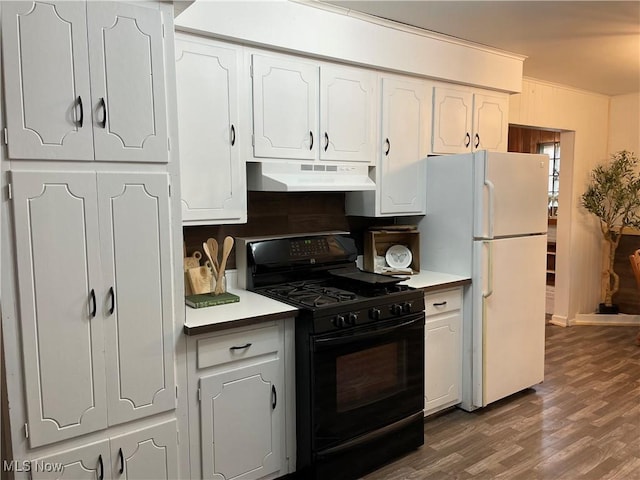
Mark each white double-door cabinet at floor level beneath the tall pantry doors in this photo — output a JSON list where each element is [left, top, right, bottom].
[[30, 420, 178, 480]]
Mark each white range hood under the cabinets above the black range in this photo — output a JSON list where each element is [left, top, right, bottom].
[[247, 162, 376, 192]]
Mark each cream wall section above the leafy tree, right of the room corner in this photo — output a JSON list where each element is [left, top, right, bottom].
[[609, 92, 640, 156]]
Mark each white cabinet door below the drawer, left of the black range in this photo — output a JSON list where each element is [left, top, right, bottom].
[[200, 359, 284, 480]]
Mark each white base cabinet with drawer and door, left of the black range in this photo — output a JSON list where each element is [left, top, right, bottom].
[[188, 321, 295, 480]]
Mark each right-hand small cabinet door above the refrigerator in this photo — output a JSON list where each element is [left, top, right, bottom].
[[473, 94, 509, 152]]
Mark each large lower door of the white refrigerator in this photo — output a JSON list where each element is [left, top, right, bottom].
[[473, 235, 547, 406]]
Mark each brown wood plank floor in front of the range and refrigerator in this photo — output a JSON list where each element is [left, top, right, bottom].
[[364, 325, 640, 480]]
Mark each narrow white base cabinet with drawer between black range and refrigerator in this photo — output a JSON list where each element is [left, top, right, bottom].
[[424, 287, 462, 416]]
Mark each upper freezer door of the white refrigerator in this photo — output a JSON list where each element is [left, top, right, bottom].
[[473, 151, 549, 238]]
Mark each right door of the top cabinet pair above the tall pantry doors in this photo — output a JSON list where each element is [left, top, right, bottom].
[[87, 2, 168, 162]]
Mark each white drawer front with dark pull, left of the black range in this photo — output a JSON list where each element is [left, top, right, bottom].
[[196, 325, 281, 369]]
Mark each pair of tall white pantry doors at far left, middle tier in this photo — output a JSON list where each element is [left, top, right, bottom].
[[11, 171, 175, 447]]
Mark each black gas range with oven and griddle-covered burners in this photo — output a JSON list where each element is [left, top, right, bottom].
[[236, 233, 424, 480]]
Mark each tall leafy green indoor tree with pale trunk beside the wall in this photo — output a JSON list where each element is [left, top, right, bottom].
[[581, 150, 640, 313]]
